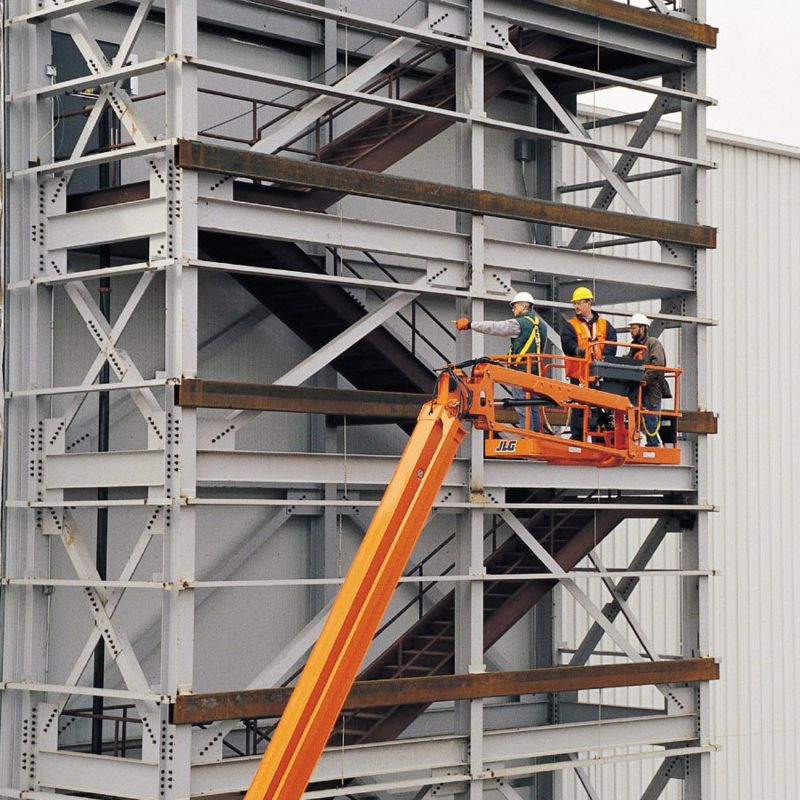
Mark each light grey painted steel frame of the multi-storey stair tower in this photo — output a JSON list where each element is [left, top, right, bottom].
[[0, 0, 714, 800]]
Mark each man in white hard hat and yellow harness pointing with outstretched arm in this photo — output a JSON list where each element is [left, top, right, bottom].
[[454, 292, 547, 432]]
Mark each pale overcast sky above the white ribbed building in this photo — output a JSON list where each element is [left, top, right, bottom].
[[596, 0, 800, 147]]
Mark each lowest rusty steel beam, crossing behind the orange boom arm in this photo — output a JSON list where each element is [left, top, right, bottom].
[[170, 658, 719, 725]]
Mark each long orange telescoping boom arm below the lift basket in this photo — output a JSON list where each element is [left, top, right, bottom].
[[245, 404, 465, 800]]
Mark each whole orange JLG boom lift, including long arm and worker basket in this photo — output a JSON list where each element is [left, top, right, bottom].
[[245, 354, 680, 800]]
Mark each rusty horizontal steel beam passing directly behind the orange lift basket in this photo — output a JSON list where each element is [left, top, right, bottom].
[[176, 378, 717, 433]]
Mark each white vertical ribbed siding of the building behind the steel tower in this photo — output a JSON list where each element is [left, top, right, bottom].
[[560, 122, 800, 800]]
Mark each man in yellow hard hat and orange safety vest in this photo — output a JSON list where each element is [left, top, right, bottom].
[[561, 286, 617, 439]]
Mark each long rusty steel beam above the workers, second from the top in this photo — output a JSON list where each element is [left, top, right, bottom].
[[176, 140, 717, 248]]
